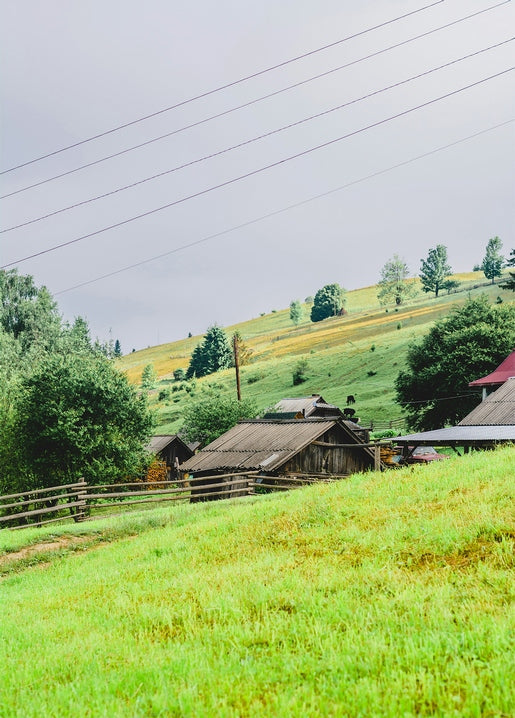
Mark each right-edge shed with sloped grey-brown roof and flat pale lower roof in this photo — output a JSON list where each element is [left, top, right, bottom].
[[395, 377, 515, 451]]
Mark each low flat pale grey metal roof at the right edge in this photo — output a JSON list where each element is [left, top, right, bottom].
[[392, 425, 515, 446]]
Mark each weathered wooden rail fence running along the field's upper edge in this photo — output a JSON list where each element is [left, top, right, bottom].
[[0, 471, 342, 529]]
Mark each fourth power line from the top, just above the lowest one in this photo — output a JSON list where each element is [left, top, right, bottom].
[[0, 67, 515, 269]]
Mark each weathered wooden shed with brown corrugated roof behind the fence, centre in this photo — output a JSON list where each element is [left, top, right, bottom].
[[180, 418, 374, 500]]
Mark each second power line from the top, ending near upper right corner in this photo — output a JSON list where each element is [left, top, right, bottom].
[[0, 0, 511, 200]]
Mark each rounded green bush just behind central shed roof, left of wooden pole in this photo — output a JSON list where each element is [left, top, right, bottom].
[[181, 398, 258, 446]]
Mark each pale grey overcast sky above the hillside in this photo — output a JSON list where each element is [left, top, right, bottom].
[[0, 0, 515, 353]]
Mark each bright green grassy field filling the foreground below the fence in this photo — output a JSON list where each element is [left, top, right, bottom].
[[0, 447, 515, 718]]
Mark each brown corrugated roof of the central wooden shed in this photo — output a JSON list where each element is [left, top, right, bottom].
[[181, 418, 368, 472]]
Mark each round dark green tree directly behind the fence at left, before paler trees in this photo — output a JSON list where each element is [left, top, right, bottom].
[[11, 354, 152, 491]]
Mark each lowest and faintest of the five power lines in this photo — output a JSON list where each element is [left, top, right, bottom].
[[54, 119, 515, 296]]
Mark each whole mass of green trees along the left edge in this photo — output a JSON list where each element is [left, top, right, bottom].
[[0, 270, 153, 494]]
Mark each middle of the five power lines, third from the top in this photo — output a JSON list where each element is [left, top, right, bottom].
[[0, 37, 515, 234]]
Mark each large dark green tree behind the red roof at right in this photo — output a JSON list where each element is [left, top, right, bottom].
[[395, 296, 515, 430]]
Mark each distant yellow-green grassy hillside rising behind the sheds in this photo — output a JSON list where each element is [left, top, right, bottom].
[[120, 272, 513, 433]]
